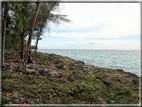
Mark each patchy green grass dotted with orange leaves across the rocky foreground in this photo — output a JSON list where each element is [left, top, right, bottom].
[[2, 52, 139, 104]]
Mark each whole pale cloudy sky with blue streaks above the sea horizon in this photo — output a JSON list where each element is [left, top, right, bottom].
[[32, 3, 140, 50]]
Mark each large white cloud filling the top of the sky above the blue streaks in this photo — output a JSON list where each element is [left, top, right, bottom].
[[51, 3, 140, 31]]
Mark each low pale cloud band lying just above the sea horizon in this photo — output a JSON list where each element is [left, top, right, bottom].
[[44, 40, 140, 50]]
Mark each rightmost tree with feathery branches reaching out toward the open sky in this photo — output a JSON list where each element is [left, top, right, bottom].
[[34, 2, 71, 54]]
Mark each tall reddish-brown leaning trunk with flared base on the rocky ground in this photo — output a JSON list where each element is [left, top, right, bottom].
[[25, 2, 40, 63]]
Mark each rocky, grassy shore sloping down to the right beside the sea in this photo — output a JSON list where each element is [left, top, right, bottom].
[[2, 52, 139, 104]]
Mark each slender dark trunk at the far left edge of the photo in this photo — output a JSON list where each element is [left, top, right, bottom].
[[2, 3, 8, 65]]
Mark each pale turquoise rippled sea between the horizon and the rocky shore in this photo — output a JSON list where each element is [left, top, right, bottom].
[[37, 49, 141, 76]]
